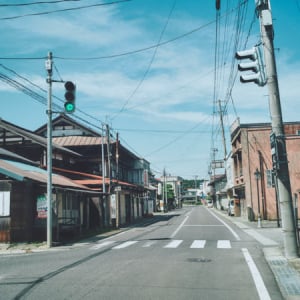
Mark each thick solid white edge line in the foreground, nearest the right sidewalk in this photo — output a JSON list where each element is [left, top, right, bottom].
[[242, 248, 271, 300]]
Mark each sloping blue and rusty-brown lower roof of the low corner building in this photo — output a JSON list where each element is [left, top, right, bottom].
[[0, 159, 88, 190]]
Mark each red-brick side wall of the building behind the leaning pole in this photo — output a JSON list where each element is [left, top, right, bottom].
[[235, 124, 300, 220]]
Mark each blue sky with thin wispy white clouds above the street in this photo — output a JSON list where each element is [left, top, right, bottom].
[[0, 0, 300, 179]]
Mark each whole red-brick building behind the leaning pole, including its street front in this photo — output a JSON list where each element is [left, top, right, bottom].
[[231, 120, 300, 220]]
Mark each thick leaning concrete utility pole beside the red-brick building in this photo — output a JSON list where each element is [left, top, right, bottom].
[[255, 0, 298, 259]]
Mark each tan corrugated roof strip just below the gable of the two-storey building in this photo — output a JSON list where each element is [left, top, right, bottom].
[[52, 136, 106, 147]]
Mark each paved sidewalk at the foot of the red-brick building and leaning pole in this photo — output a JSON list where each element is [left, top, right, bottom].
[[214, 209, 300, 300]]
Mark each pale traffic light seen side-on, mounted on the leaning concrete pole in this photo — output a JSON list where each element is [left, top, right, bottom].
[[235, 46, 267, 86]]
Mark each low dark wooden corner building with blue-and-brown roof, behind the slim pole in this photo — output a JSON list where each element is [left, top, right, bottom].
[[0, 148, 93, 242]]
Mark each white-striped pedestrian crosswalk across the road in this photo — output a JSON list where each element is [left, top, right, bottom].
[[89, 240, 232, 250]]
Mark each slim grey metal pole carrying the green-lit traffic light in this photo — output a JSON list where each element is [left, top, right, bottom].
[[45, 52, 52, 248]]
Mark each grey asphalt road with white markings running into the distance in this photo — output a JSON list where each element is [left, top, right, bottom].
[[0, 206, 282, 300]]
